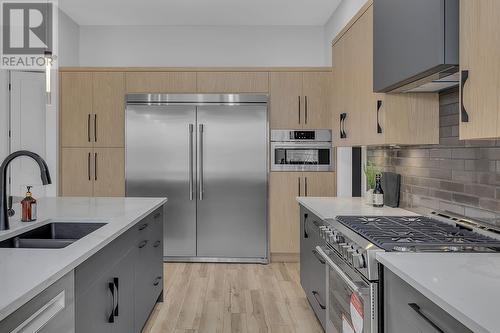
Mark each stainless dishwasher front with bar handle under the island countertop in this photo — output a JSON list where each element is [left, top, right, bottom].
[[0, 272, 75, 333]]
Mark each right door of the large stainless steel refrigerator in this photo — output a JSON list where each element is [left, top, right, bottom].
[[197, 104, 268, 258]]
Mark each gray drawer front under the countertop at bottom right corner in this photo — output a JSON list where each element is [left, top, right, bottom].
[[384, 268, 472, 333]]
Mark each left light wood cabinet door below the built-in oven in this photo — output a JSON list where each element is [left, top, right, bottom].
[[269, 172, 304, 255]]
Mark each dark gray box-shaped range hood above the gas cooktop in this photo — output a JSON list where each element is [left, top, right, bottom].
[[373, 0, 459, 93]]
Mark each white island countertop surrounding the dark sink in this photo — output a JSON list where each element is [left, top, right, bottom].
[[0, 198, 167, 320]]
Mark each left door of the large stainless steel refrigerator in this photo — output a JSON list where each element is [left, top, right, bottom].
[[125, 104, 196, 257]]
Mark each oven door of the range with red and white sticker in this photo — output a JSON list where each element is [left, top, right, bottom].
[[316, 246, 378, 333]]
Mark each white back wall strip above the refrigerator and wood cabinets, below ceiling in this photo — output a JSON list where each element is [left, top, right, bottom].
[[80, 26, 325, 67]]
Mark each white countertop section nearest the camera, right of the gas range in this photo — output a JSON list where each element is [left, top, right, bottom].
[[377, 252, 500, 333]]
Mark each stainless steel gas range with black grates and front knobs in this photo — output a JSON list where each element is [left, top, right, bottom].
[[316, 213, 500, 333]]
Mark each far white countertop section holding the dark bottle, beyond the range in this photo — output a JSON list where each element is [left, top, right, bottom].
[[297, 197, 417, 220]]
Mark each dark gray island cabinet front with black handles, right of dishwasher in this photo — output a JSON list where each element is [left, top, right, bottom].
[[75, 208, 163, 333]]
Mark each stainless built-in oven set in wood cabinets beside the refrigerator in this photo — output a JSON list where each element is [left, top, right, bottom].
[[271, 130, 334, 171]]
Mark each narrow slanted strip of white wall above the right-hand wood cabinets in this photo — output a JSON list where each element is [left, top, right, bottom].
[[324, 0, 367, 66]]
